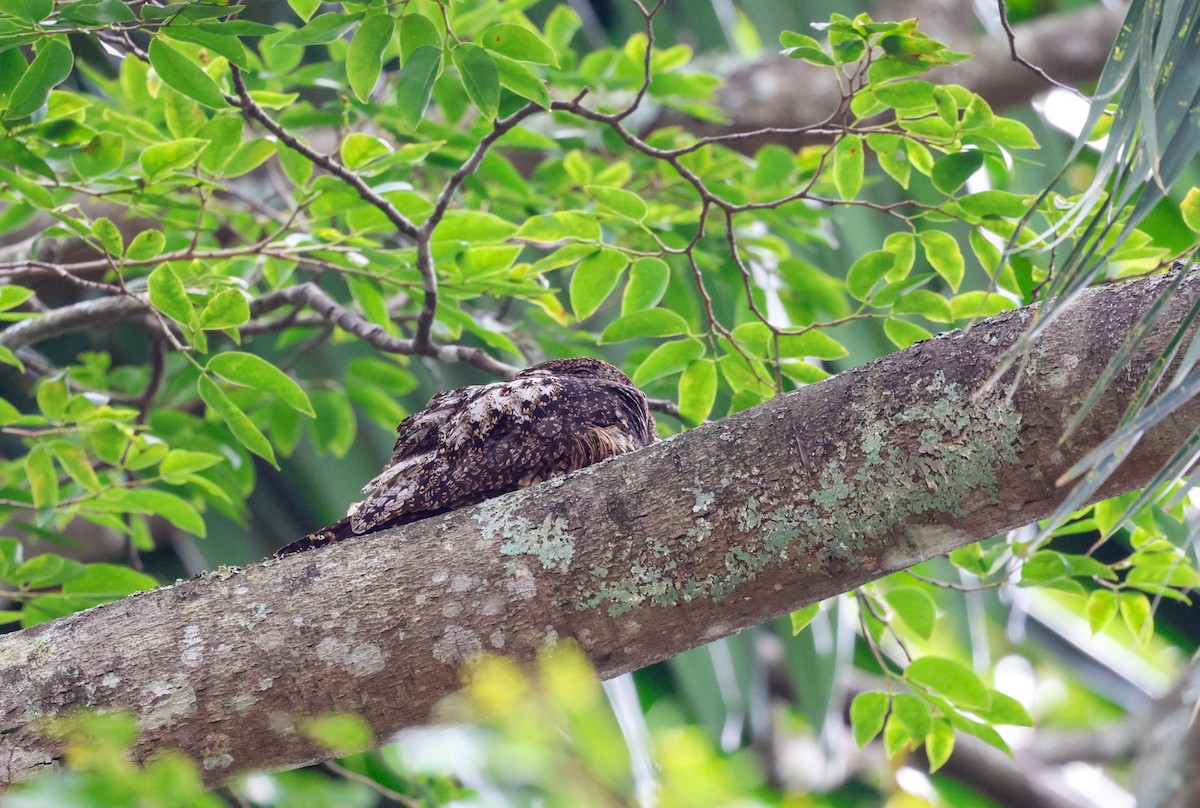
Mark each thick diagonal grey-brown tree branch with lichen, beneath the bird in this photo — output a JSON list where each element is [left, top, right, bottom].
[[0, 273, 1200, 782]]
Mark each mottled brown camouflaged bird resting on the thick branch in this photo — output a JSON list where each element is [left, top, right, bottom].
[[275, 358, 659, 556]]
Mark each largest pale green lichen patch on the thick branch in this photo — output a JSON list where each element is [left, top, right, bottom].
[[577, 371, 1021, 616]]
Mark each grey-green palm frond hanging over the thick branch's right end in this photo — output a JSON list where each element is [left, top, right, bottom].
[[992, 0, 1200, 540]]
